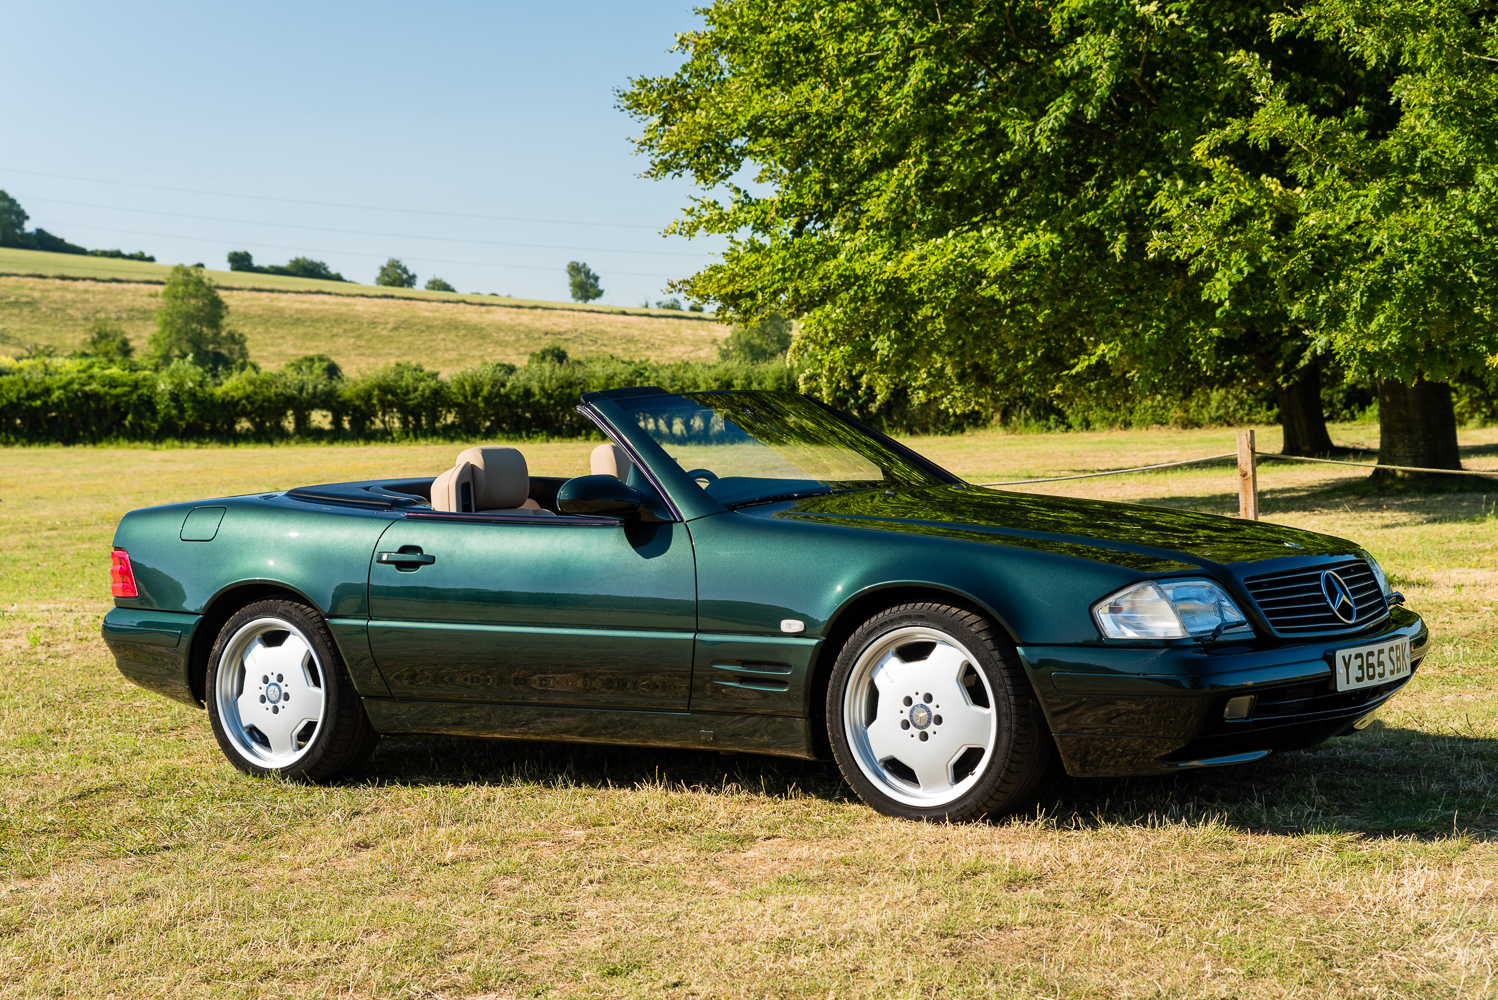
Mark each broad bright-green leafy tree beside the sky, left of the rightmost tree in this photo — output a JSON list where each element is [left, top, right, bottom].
[[620, 0, 1366, 451]]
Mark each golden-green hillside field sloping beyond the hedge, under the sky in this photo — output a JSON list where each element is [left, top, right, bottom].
[[0, 249, 728, 374]]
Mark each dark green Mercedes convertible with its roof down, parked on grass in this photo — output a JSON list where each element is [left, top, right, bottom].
[[103, 386, 1429, 820]]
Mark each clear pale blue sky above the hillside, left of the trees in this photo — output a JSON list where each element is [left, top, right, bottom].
[[0, 0, 724, 305]]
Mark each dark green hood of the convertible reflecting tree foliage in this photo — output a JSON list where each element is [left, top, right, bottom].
[[740, 485, 1362, 572]]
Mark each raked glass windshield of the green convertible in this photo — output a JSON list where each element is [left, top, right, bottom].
[[619, 392, 944, 506]]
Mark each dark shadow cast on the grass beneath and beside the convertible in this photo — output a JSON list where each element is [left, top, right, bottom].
[[363, 722, 1498, 840]]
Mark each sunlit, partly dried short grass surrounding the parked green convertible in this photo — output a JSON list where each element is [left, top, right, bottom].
[[0, 427, 1498, 1000]]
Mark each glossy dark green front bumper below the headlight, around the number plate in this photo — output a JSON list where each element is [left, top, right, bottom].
[[1020, 608, 1431, 777]]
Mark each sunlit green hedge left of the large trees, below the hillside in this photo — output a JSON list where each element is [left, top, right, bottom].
[[0, 358, 795, 445]]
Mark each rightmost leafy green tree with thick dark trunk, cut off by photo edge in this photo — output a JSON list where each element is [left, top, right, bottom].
[[1161, 0, 1498, 469]]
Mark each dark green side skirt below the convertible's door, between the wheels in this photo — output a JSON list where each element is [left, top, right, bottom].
[[363, 698, 815, 760]]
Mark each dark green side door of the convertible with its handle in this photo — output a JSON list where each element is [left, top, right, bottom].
[[369, 513, 697, 710]]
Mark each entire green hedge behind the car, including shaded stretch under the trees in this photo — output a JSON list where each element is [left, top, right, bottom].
[[0, 355, 1306, 445]]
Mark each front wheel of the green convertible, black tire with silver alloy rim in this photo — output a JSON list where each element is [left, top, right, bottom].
[[827, 603, 1055, 822]]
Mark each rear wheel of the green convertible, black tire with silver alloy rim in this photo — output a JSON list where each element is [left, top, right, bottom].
[[204, 600, 379, 781]]
